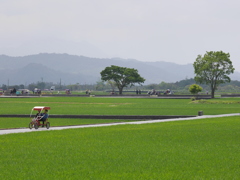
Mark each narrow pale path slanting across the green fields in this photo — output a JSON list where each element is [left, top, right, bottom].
[[0, 113, 240, 135]]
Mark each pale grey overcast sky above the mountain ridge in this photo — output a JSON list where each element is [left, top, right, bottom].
[[0, 0, 240, 71]]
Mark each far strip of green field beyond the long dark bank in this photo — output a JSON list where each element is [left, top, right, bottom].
[[0, 97, 240, 115]]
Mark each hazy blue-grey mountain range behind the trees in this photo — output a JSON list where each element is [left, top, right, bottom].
[[0, 53, 240, 85]]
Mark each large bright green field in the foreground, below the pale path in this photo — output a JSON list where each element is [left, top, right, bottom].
[[0, 116, 240, 180]]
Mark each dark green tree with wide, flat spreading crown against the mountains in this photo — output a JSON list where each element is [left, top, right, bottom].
[[100, 65, 145, 94]]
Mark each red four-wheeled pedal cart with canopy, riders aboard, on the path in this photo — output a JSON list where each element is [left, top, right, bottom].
[[29, 106, 51, 129]]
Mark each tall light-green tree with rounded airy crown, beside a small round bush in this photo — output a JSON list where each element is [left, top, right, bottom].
[[193, 51, 234, 98]]
